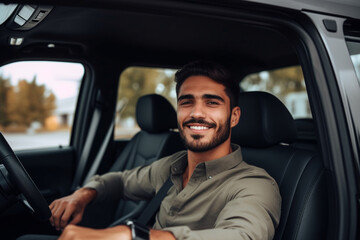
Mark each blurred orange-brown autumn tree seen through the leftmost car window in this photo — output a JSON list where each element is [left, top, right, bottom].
[[0, 77, 55, 127]]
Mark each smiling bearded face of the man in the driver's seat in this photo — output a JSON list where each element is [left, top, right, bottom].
[[177, 76, 240, 152]]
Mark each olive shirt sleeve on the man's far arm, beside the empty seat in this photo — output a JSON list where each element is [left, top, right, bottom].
[[83, 158, 169, 202]]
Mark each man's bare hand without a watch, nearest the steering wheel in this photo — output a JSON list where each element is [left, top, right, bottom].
[[49, 188, 96, 231]]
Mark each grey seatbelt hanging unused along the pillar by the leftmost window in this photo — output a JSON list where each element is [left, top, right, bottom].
[[71, 91, 103, 190]]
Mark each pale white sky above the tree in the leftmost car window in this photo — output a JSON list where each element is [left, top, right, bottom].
[[0, 61, 84, 100]]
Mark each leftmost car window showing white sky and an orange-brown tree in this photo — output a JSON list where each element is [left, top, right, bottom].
[[0, 61, 84, 150]]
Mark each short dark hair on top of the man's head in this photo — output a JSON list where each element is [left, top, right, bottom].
[[175, 60, 240, 109]]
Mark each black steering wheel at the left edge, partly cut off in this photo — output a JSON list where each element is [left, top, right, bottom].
[[0, 133, 51, 220]]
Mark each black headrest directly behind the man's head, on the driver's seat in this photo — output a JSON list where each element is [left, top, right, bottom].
[[232, 92, 296, 148]]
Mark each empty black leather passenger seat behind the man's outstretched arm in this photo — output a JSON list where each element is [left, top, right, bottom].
[[81, 94, 184, 227]]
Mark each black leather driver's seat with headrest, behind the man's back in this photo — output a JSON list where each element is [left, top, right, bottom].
[[232, 92, 328, 240]]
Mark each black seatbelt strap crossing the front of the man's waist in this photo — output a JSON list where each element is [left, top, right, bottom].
[[136, 177, 173, 225]]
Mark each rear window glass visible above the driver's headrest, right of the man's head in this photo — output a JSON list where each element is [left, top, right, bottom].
[[240, 66, 311, 119]]
